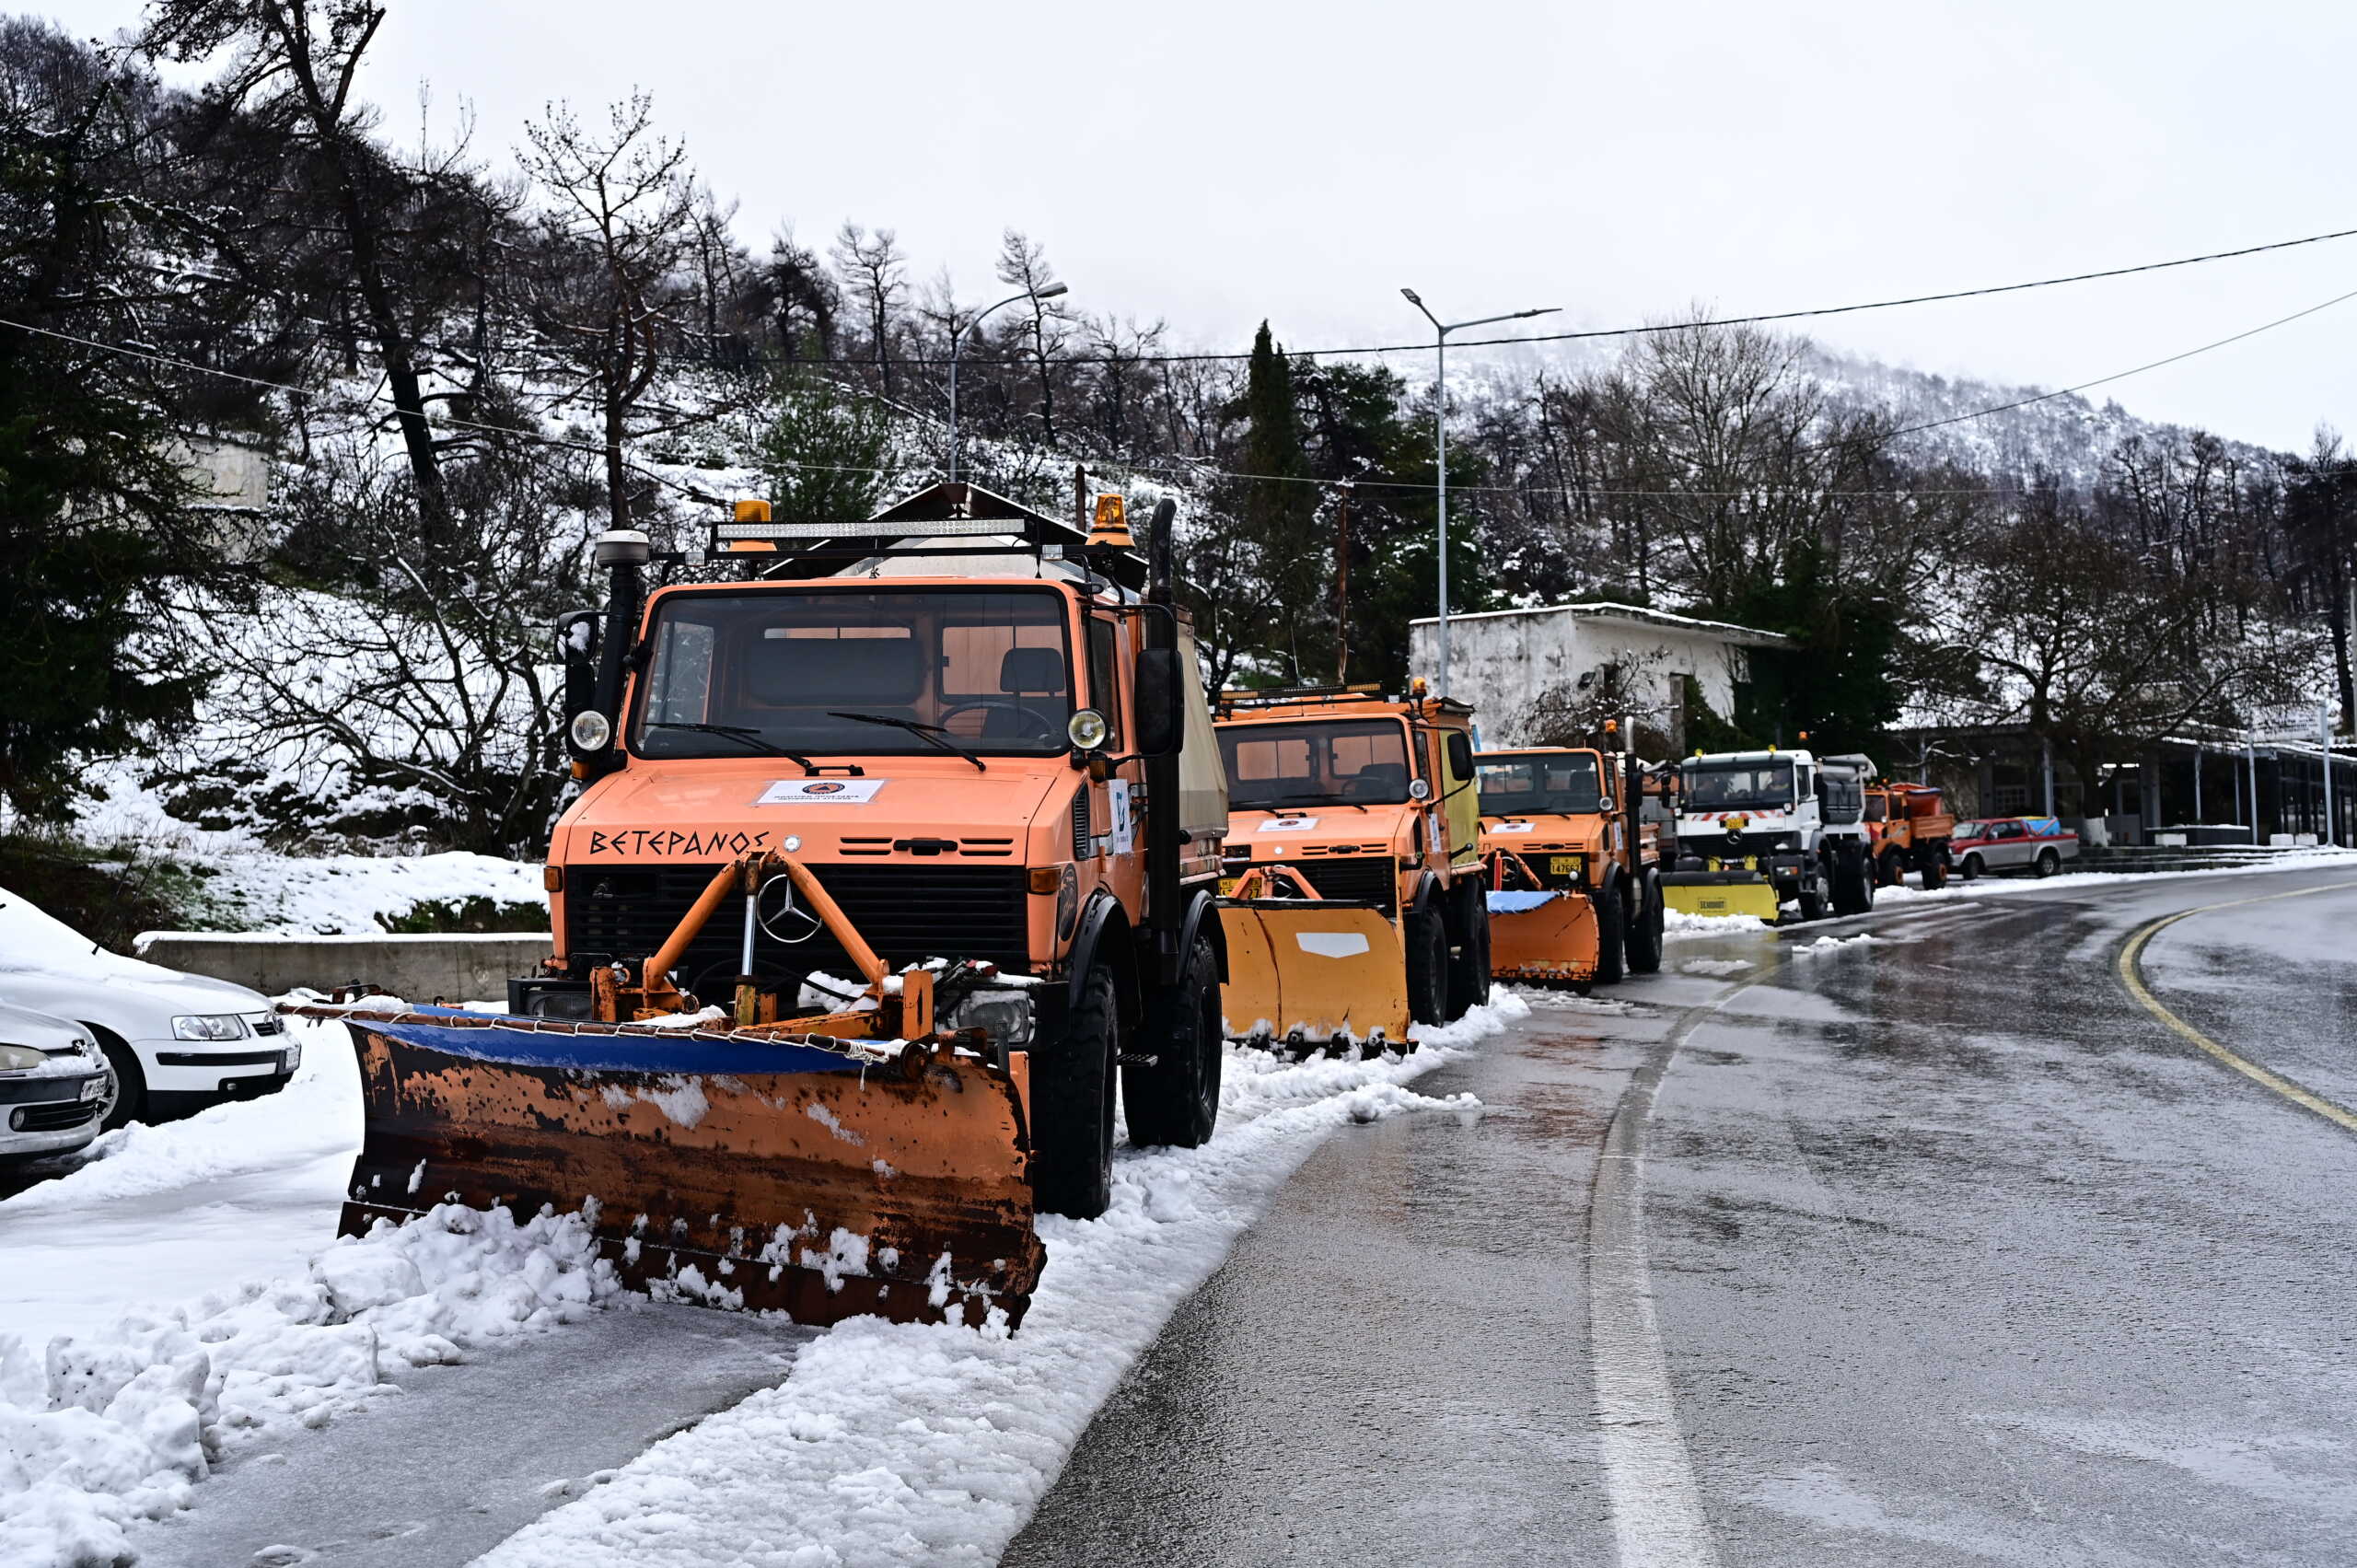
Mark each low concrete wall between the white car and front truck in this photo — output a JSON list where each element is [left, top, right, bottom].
[[134, 932, 554, 1002]]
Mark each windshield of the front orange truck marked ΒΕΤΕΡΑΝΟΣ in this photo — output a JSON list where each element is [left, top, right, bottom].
[[632, 587, 1073, 757]]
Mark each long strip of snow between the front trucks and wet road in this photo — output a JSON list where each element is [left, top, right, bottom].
[[479, 991, 1527, 1568]]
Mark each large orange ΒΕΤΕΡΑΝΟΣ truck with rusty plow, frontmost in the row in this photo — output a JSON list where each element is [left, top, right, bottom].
[[301, 483, 1228, 1323]]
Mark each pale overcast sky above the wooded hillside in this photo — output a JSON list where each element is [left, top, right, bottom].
[[26, 0, 2357, 446]]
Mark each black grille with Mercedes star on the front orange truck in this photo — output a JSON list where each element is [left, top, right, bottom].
[[565, 863, 1030, 991]]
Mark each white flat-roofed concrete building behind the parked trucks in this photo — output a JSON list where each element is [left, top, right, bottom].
[[1407, 609, 1751, 748]]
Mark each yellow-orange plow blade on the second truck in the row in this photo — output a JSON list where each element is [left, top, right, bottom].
[[1219, 899, 1407, 1044]]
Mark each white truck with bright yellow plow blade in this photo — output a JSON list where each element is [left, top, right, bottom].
[[1662, 748, 1874, 920]]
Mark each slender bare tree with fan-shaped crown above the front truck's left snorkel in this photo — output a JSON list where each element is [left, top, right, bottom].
[[523, 92, 698, 528]]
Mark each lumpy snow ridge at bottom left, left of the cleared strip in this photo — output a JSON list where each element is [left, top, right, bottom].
[[0, 1207, 620, 1568]]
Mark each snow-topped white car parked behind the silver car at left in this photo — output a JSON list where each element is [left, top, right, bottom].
[[0, 889, 302, 1127]]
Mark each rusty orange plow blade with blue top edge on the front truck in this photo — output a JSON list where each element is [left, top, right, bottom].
[[304, 1009, 1044, 1325]]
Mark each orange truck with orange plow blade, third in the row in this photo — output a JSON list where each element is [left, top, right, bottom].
[[1476, 726, 1664, 991]]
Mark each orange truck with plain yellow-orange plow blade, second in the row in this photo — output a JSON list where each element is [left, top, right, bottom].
[[1216, 679, 1490, 1054]]
